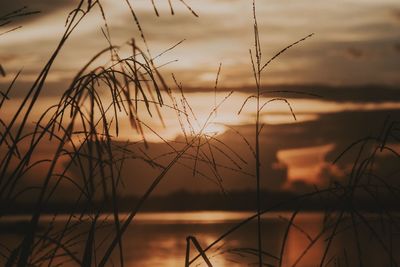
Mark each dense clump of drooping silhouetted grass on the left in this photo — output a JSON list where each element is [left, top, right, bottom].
[[0, 0, 200, 266]]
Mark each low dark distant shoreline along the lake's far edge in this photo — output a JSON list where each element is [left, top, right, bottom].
[[0, 191, 400, 216]]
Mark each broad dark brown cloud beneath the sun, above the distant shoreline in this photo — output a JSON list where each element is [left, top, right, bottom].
[[62, 110, 400, 198]]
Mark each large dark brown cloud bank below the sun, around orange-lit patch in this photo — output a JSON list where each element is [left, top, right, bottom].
[[8, 105, 400, 204]]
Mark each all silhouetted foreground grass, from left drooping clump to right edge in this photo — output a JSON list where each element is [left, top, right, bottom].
[[0, 0, 400, 267]]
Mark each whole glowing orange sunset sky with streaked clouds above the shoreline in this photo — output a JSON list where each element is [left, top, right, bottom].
[[0, 0, 400, 200]]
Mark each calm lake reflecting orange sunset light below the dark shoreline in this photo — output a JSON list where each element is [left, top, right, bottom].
[[0, 211, 400, 267]]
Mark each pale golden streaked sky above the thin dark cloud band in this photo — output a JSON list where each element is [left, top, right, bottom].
[[0, 0, 400, 88]]
